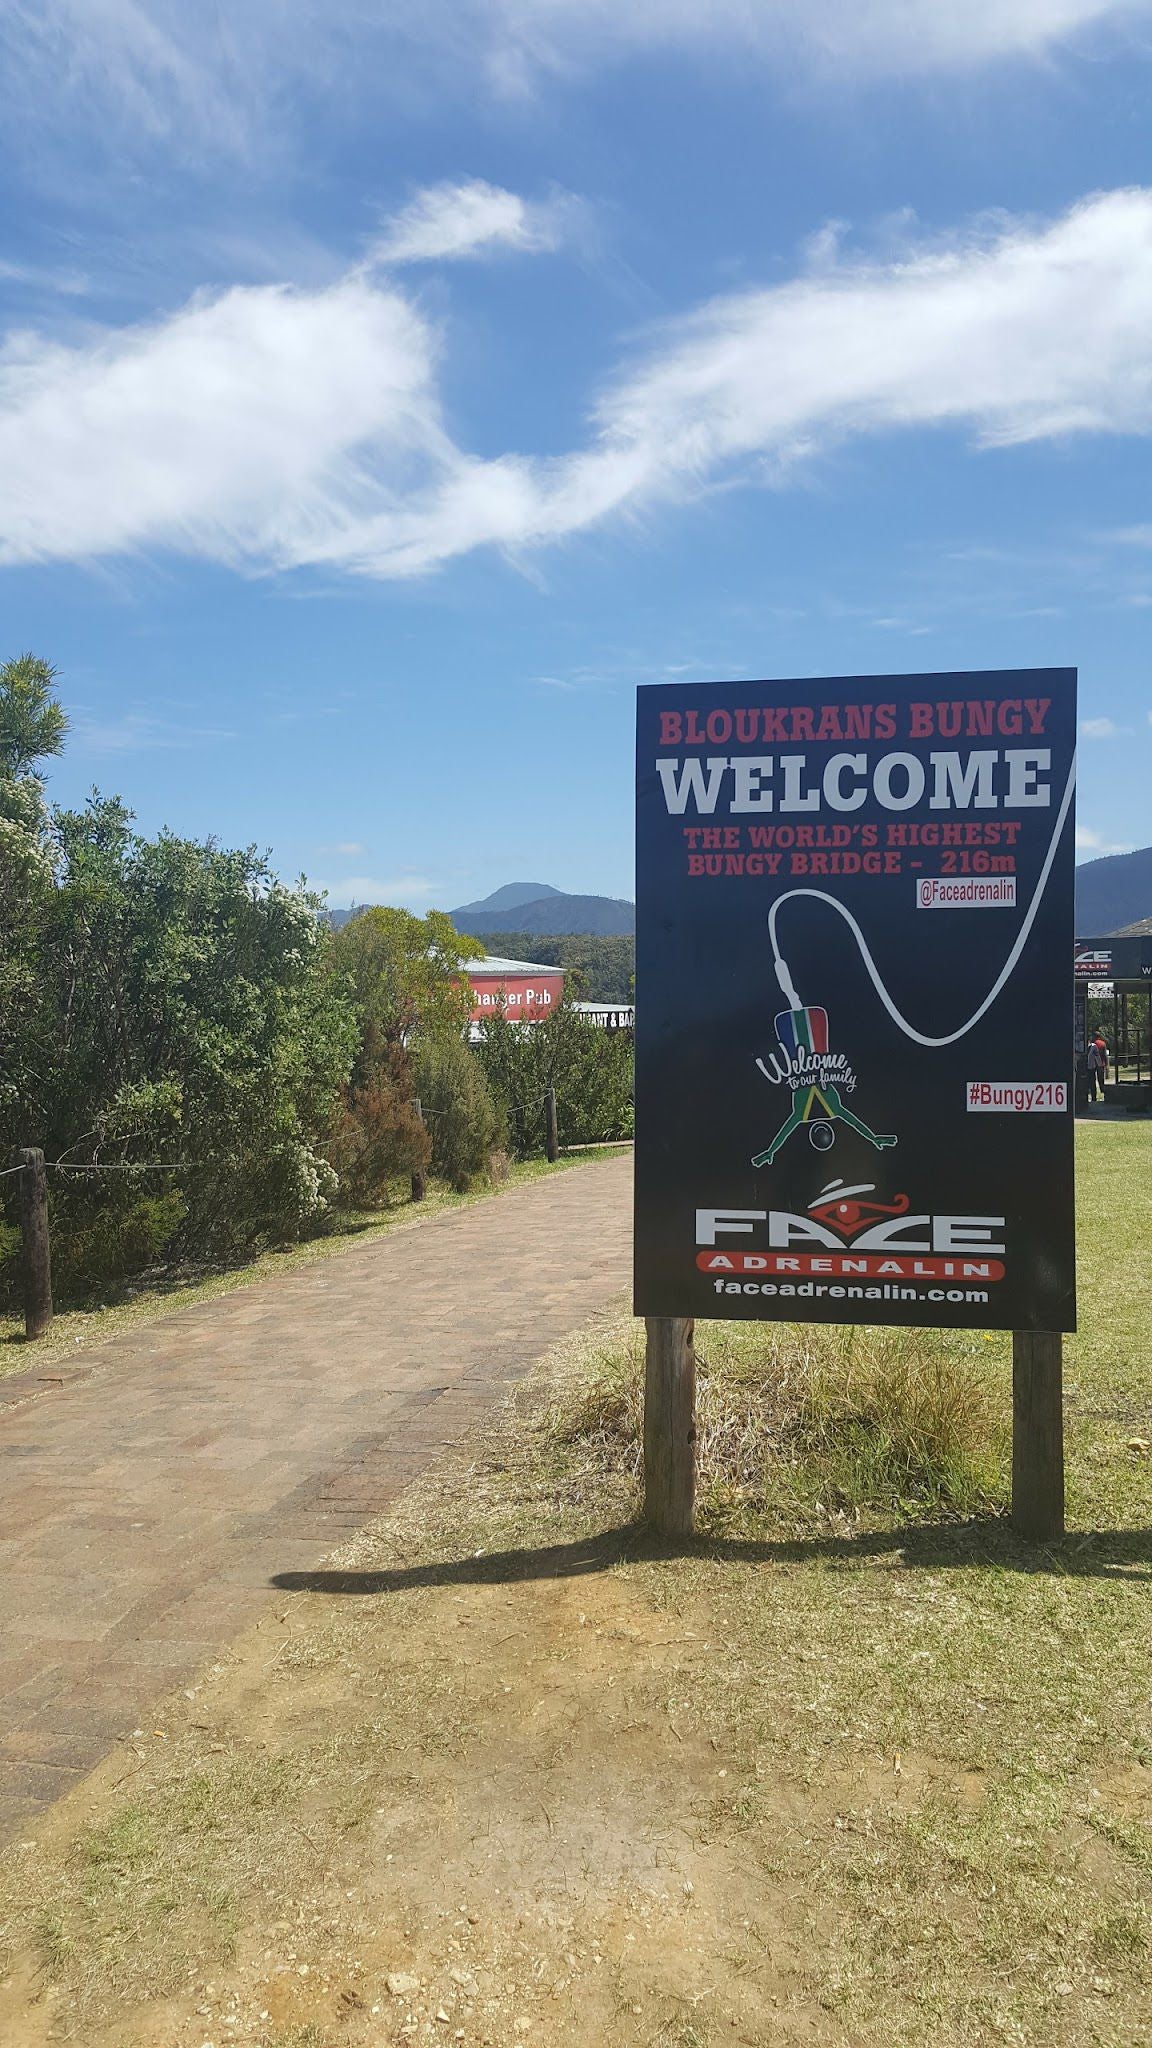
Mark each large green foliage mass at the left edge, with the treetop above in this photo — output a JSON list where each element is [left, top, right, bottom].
[[0, 657, 357, 1290]]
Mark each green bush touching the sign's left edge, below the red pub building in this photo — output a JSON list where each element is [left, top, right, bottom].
[[476, 1004, 633, 1157]]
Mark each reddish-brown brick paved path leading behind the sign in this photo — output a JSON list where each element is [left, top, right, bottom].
[[0, 1159, 631, 1839]]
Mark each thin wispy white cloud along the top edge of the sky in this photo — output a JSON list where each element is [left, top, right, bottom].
[[0, 0, 1152, 163]]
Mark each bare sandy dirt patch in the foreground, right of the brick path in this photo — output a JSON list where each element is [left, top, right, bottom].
[[0, 1490, 844, 2048]]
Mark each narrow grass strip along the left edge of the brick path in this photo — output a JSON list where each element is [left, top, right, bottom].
[[0, 1147, 619, 1378]]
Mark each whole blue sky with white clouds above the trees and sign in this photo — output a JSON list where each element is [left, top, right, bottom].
[[0, 0, 1152, 909]]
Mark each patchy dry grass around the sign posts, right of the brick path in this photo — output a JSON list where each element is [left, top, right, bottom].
[[0, 1122, 1152, 2048]]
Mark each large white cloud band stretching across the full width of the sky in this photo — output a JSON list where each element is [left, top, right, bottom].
[[0, 190, 1152, 578]]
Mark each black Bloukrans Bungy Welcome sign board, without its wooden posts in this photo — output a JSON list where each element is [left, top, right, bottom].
[[635, 670, 1076, 1331]]
